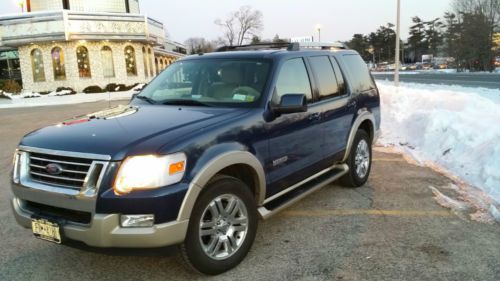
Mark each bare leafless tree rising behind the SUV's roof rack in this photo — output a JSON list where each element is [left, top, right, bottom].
[[215, 6, 264, 46]]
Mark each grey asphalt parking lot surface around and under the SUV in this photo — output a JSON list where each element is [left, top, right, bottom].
[[0, 102, 500, 281]]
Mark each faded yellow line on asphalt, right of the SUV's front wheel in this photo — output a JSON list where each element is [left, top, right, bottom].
[[282, 209, 452, 217]]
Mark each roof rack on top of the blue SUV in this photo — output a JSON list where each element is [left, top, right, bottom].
[[216, 42, 347, 52]]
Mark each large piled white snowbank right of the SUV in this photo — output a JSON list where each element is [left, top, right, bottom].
[[377, 81, 500, 219]]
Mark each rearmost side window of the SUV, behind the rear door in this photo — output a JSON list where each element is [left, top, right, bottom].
[[343, 55, 375, 93]]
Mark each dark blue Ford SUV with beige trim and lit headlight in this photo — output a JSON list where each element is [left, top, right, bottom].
[[12, 44, 380, 274]]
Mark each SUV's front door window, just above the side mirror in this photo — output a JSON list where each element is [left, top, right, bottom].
[[274, 58, 312, 103]]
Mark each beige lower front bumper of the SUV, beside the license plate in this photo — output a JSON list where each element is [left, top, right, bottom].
[[12, 198, 189, 248]]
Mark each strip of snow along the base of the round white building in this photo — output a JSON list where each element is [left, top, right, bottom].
[[0, 84, 144, 109]]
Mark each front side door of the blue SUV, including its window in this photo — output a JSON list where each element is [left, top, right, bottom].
[[266, 58, 323, 197]]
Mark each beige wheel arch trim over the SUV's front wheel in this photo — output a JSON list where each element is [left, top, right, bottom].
[[177, 151, 266, 221]]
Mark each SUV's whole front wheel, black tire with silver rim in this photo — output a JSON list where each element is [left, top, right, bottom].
[[180, 176, 258, 275]]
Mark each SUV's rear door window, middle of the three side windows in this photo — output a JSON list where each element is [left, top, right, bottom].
[[309, 56, 339, 100]]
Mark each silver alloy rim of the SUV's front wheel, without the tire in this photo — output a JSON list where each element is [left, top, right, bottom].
[[200, 194, 248, 260]]
